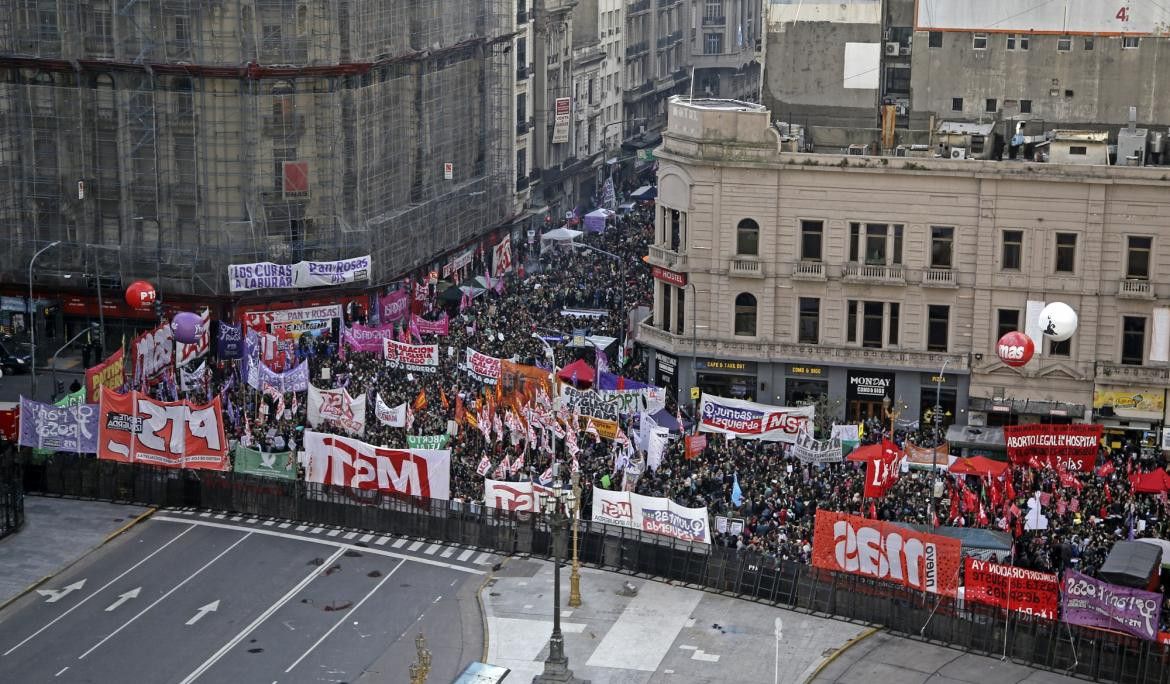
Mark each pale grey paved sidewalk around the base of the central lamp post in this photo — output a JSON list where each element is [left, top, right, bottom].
[[481, 558, 867, 684]]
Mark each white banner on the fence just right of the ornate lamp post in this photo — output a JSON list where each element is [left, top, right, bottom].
[[593, 489, 711, 544]]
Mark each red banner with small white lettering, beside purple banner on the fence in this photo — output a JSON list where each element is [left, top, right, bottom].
[[963, 558, 1060, 620]]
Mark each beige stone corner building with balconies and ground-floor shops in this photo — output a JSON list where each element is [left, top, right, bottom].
[[639, 97, 1170, 448]]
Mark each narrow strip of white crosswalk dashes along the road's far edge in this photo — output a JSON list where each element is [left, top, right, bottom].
[[160, 507, 500, 566]]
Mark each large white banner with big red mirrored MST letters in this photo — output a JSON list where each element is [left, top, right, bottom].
[[304, 430, 450, 500]]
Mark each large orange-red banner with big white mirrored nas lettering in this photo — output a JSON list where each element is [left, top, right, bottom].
[[812, 510, 961, 596]]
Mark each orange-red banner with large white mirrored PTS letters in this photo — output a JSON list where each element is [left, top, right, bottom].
[[97, 387, 228, 470]]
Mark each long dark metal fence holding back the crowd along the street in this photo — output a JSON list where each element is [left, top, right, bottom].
[[9, 455, 1170, 684]]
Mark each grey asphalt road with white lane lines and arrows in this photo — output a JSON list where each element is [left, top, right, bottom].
[[0, 511, 497, 684]]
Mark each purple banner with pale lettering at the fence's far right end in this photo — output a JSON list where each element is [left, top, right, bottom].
[[1062, 571, 1162, 641]]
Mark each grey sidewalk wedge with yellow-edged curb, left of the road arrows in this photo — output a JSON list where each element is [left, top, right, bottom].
[[0, 496, 149, 604]]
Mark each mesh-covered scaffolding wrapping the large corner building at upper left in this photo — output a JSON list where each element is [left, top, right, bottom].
[[0, 0, 515, 296]]
